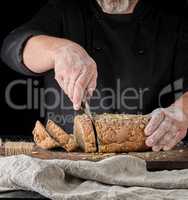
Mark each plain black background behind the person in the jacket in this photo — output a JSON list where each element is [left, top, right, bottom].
[[0, 0, 185, 137]]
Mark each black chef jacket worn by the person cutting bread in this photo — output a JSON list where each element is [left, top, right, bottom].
[[2, 0, 188, 132]]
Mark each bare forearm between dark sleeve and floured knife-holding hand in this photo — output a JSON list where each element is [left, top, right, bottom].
[[23, 35, 68, 73]]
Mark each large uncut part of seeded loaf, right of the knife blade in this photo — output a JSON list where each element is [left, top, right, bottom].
[[95, 114, 149, 153]]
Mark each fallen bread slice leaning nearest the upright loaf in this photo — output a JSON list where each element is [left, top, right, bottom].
[[46, 120, 78, 152]]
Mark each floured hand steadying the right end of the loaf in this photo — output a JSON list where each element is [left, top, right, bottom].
[[145, 105, 188, 151]]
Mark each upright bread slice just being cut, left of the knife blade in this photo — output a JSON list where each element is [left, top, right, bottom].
[[74, 114, 97, 153]]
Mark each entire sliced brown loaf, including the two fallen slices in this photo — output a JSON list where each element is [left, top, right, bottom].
[[33, 114, 149, 153]]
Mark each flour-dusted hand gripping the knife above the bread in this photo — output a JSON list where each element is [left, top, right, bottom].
[[54, 41, 97, 110]]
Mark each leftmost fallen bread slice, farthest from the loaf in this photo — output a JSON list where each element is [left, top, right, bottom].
[[32, 121, 60, 149]]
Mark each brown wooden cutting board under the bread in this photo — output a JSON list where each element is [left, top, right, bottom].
[[32, 147, 188, 171]]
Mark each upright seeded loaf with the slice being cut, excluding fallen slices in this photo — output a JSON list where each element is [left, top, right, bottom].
[[74, 114, 149, 153]]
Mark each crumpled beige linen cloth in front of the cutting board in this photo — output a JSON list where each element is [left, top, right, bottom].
[[0, 155, 188, 200]]
